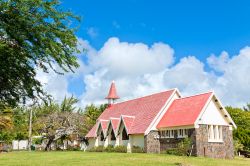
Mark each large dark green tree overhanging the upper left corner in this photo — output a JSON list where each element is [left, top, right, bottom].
[[0, 0, 79, 106]]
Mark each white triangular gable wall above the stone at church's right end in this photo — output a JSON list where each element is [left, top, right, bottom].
[[198, 99, 229, 125]]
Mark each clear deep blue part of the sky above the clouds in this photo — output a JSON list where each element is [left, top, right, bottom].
[[62, 0, 250, 60]]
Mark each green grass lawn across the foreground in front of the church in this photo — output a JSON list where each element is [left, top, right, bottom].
[[0, 151, 250, 166]]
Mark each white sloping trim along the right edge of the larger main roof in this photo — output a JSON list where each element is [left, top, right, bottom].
[[144, 88, 181, 135]]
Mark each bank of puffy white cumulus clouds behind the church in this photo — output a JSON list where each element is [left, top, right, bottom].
[[38, 38, 250, 106]]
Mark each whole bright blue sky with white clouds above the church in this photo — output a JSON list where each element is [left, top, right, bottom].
[[37, 0, 250, 107]]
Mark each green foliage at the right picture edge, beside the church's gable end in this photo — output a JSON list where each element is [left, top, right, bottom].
[[226, 104, 250, 151]]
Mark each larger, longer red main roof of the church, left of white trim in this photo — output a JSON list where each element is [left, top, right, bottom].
[[86, 90, 175, 137]]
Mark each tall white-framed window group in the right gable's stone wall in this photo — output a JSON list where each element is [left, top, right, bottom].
[[208, 125, 223, 142]]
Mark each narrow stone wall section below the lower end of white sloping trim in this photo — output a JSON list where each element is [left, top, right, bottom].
[[144, 131, 160, 153]]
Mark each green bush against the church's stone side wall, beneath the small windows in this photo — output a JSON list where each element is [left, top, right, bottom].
[[166, 138, 192, 156]]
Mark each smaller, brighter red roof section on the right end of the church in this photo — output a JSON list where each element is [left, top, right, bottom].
[[157, 92, 213, 128]]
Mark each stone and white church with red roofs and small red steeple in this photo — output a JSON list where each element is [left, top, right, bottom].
[[86, 82, 236, 158]]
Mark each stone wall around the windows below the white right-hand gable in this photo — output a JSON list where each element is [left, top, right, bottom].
[[195, 125, 234, 159]]
